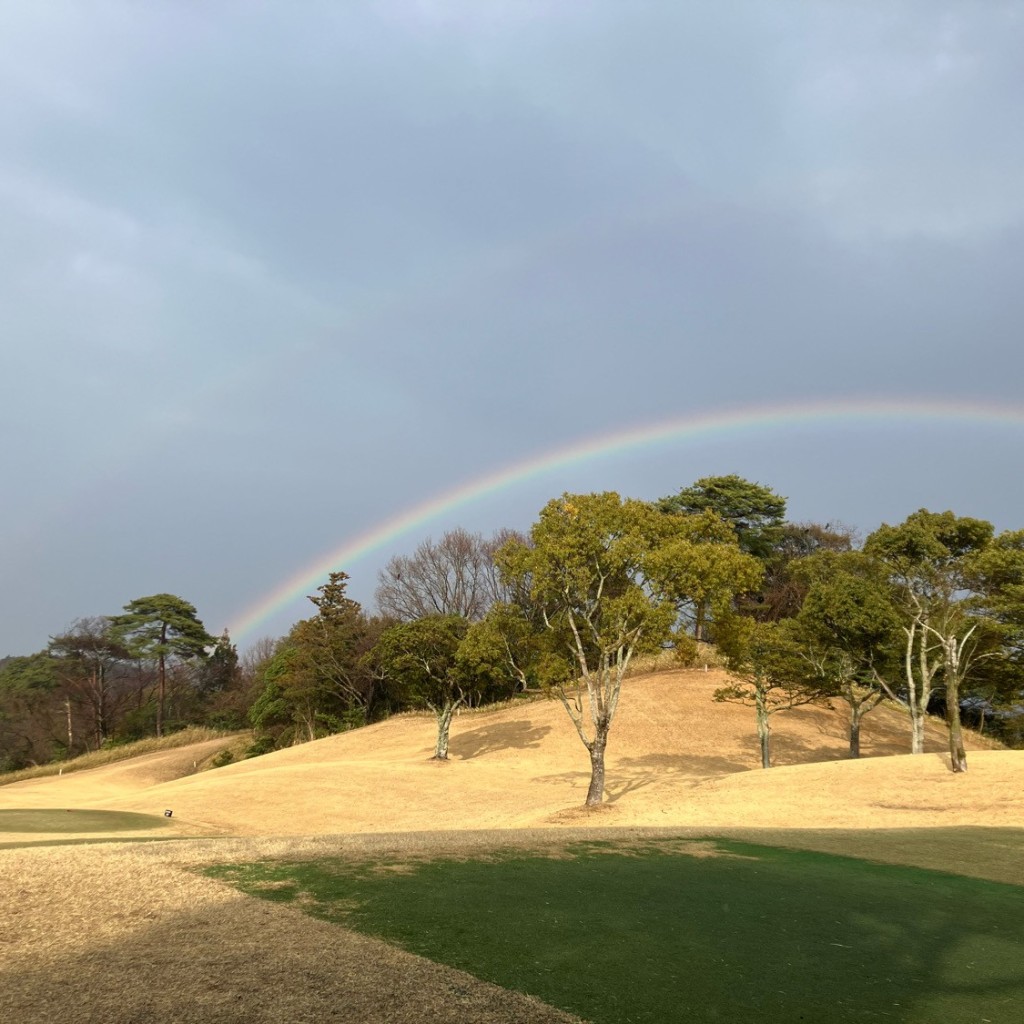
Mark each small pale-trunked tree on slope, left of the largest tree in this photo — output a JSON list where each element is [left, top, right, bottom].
[[371, 615, 477, 761]]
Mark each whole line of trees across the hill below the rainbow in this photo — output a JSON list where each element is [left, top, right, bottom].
[[0, 475, 1024, 804]]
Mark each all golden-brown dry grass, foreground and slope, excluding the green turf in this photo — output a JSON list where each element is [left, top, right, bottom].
[[0, 671, 1024, 1024]]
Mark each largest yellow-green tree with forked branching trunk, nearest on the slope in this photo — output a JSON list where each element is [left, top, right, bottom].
[[497, 493, 677, 807]]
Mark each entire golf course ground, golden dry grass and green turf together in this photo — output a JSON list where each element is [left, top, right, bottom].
[[0, 670, 1024, 1024]]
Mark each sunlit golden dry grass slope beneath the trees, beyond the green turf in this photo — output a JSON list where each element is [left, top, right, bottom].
[[0, 671, 1024, 840]]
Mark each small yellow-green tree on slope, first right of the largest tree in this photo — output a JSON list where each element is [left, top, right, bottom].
[[714, 615, 828, 768]]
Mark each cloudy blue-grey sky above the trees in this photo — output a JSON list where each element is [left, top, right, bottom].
[[0, 0, 1024, 655]]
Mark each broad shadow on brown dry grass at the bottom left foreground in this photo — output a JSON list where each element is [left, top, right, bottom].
[[0, 877, 569, 1024]]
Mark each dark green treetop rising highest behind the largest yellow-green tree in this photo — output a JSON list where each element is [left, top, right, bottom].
[[657, 473, 785, 560]]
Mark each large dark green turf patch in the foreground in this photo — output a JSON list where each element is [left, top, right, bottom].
[[212, 840, 1024, 1024]]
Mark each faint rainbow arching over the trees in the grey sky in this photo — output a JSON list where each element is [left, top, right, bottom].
[[228, 398, 1024, 643]]
